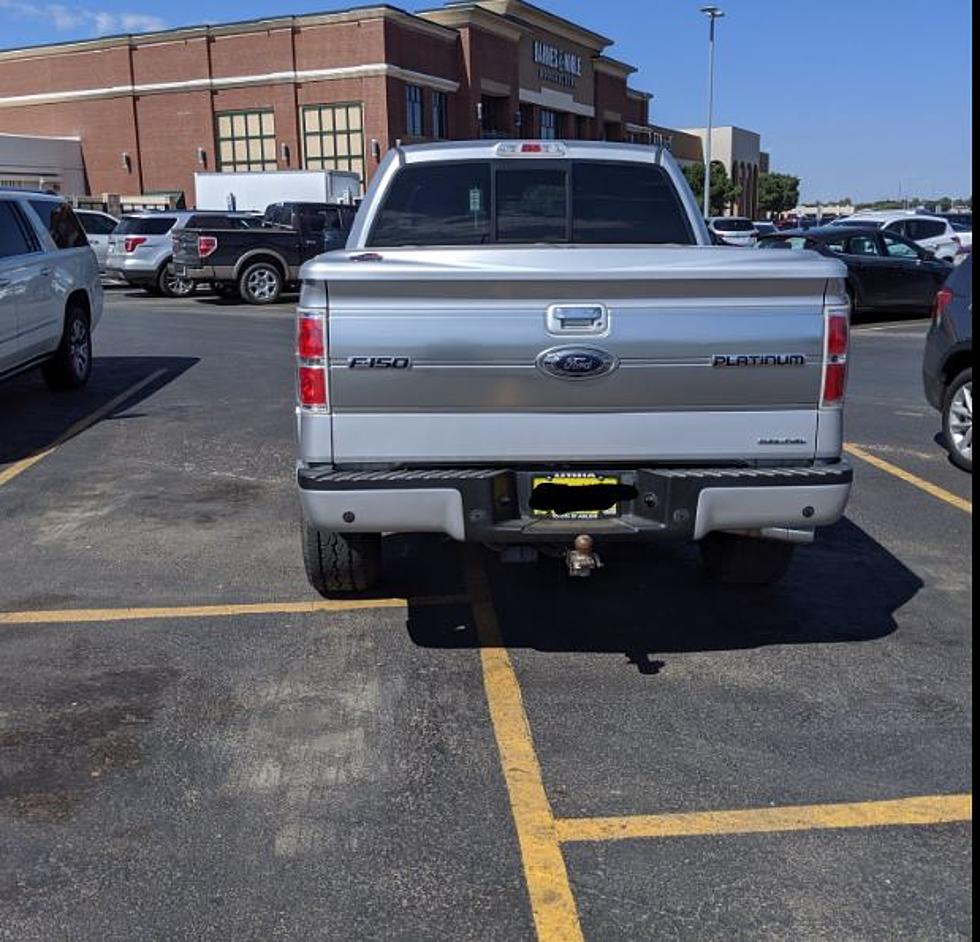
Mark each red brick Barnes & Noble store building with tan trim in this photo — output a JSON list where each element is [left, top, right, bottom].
[[0, 0, 679, 204]]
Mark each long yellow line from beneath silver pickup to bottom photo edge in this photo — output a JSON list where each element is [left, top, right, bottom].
[[465, 545, 583, 942]]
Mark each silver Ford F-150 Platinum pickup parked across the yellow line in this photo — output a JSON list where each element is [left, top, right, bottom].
[[297, 141, 851, 595]]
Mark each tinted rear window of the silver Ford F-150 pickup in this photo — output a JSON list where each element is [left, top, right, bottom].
[[368, 160, 695, 247]]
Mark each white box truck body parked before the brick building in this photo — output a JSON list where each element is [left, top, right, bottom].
[[194, 170, 361, 213]]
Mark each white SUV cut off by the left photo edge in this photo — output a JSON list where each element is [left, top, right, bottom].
[[0, 190, 102, 389]]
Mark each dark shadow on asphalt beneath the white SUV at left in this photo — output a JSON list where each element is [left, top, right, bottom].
[[0, 356, 198, 466]]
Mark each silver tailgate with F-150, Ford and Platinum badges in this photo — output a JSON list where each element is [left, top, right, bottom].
[[312, 246, 843, 465]]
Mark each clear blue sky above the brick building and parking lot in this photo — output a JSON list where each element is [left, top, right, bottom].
[[0, 0, 973, 200]]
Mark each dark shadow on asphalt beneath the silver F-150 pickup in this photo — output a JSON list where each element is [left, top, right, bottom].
[[405, 519, 923, 674]]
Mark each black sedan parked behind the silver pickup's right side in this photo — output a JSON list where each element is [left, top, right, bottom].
[[759, 225, 952, 314]]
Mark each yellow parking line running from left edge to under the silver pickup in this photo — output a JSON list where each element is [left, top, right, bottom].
[[0, 595, 469, 625]]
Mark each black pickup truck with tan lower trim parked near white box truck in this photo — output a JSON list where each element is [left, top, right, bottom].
[[173, 203, 355, 304]]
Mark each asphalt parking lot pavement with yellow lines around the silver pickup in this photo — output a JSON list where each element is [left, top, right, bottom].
[[0, 291, 972, 940]]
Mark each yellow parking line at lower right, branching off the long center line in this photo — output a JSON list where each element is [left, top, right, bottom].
[[555, 795, 973, 842]]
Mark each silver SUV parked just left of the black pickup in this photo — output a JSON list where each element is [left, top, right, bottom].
[[106, 210, 262, 298]]
